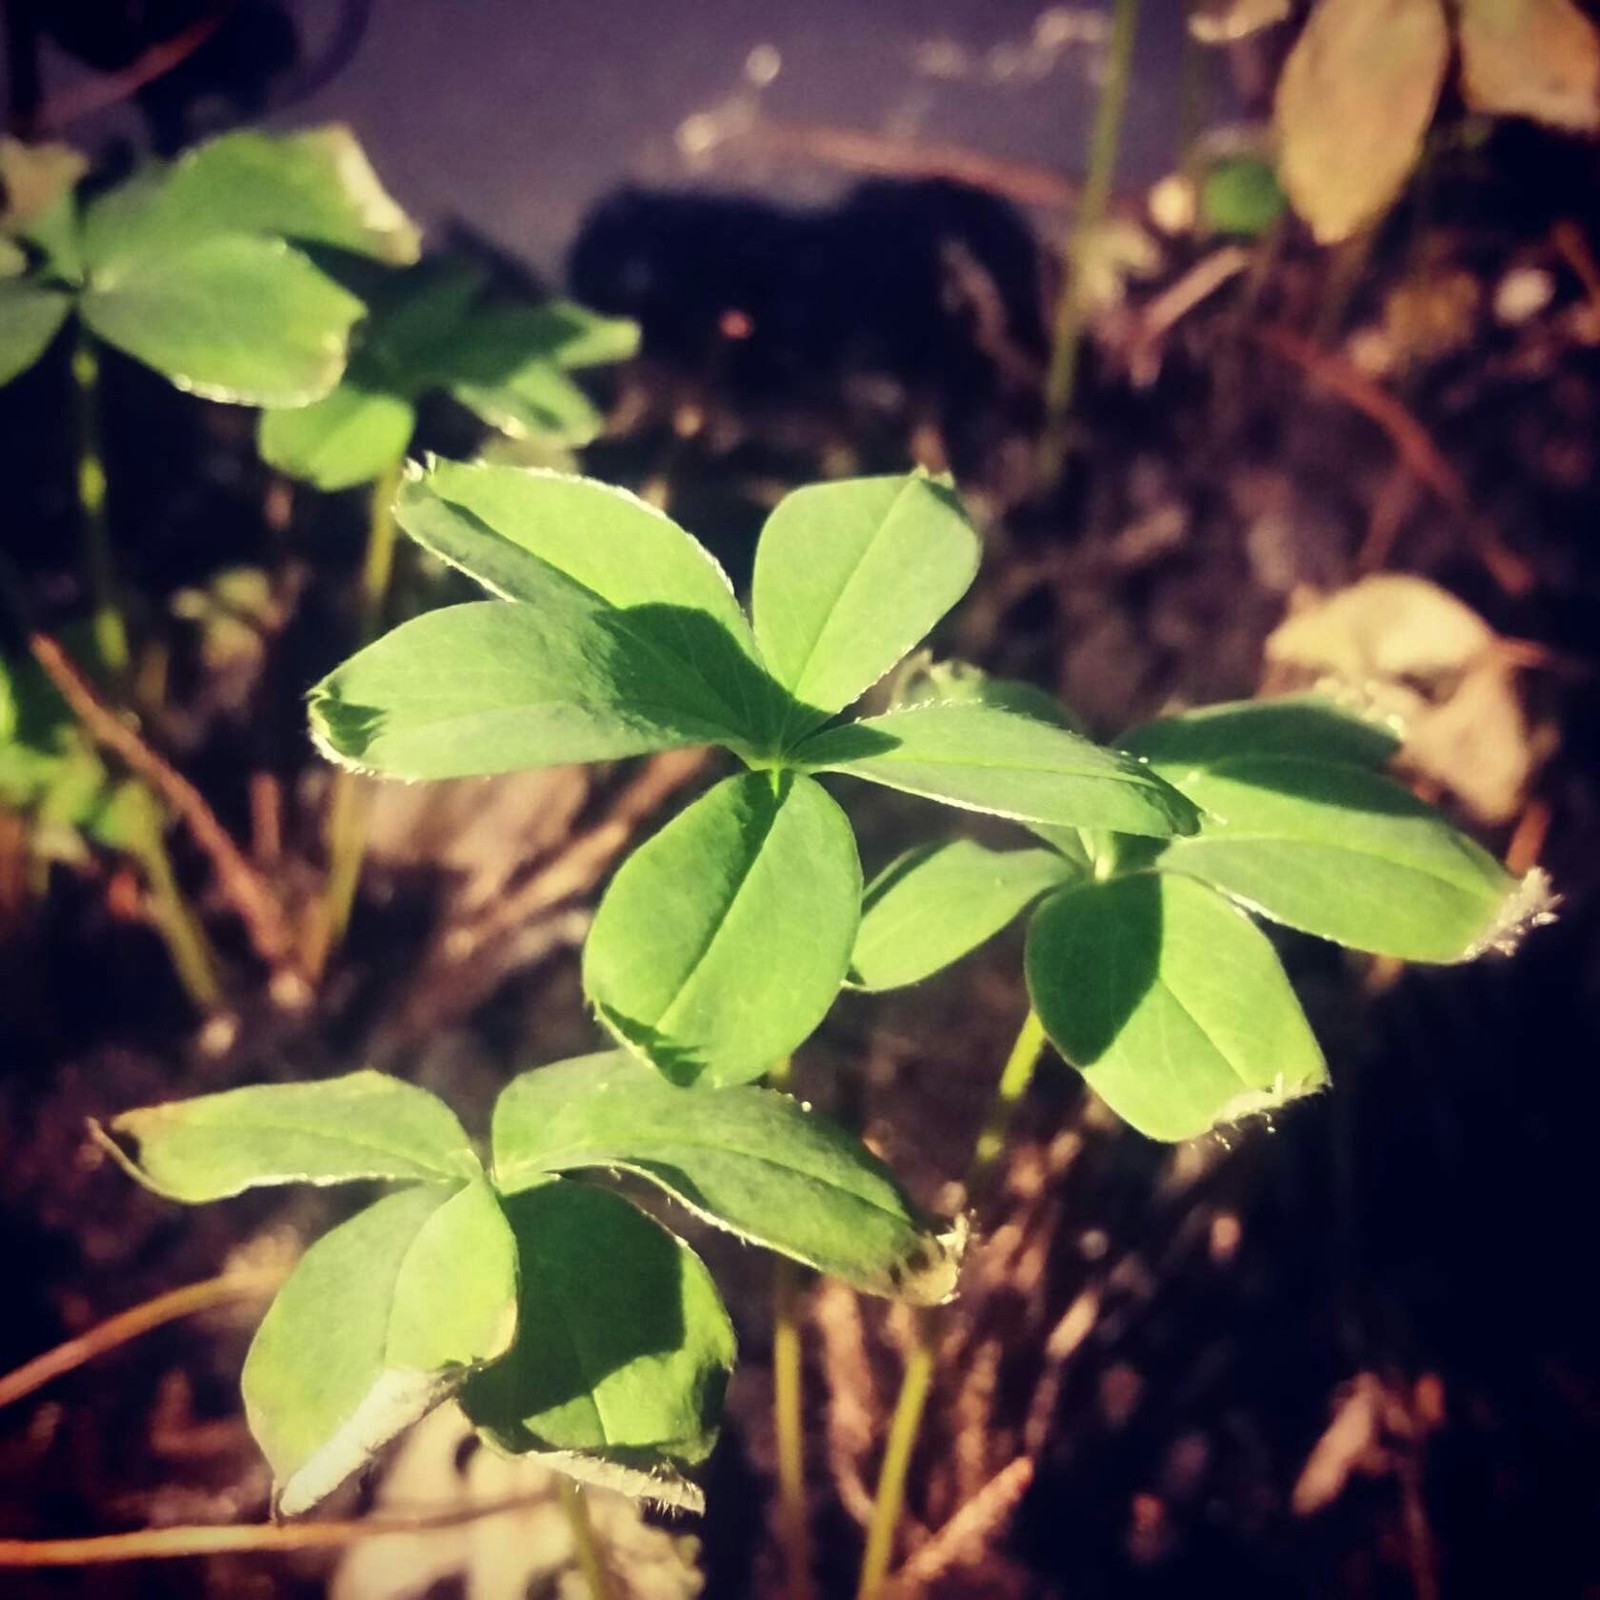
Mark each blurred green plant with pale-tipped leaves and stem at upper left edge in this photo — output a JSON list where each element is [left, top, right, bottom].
[[0, 128, 418, 678]]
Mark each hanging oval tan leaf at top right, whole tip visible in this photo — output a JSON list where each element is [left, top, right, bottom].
[[1274, 0, 1450, 245]]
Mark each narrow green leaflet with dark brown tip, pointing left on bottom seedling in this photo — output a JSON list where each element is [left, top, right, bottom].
[[90, 1070, 478, 1203]]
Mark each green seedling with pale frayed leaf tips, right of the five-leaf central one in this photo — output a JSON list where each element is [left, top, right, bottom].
[[851, 699, 1552, 1141]]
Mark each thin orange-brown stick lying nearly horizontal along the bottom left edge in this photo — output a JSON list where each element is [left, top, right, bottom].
[[0, 1491, 572, 1568]]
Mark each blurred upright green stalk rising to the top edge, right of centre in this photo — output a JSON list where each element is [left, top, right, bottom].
[[1038, 0, 1139, 490]]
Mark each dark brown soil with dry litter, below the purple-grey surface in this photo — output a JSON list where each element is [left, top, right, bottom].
[[0, 124, 1600, 1600]]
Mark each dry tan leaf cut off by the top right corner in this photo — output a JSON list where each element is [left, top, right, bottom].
[[1461, 0, 1600, 133]]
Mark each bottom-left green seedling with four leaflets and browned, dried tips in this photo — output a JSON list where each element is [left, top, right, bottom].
[[94, 1051, 958, 1515]]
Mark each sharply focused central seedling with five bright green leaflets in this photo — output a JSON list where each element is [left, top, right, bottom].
[[310, 462, 1200, 1085]]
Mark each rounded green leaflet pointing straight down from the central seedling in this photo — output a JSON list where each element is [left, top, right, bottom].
[[584, 773, 861, 1083]]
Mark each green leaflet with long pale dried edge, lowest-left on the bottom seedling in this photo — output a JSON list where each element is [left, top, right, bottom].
[[243, 1181, 517, 1517]]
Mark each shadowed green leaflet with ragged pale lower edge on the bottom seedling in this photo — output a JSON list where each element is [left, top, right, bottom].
[[461, 1179, 734, 1494]]
